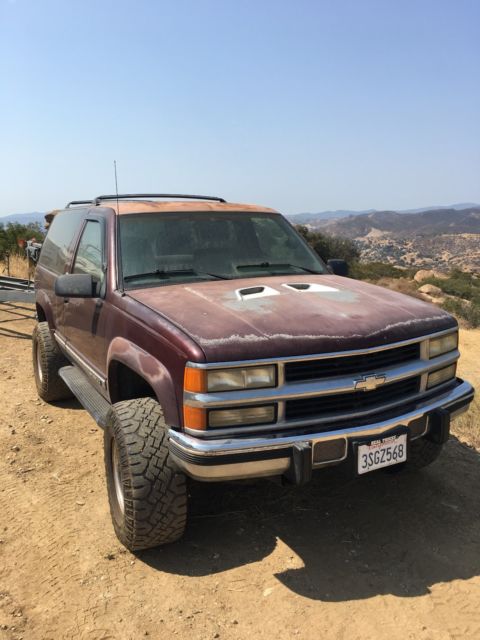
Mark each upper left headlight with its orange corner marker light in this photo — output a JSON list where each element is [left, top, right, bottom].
[[184, 364, 277, 393]]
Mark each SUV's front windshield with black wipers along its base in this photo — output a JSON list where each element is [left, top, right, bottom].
[[119, 212, 328, 289]]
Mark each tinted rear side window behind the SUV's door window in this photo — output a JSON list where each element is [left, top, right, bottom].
[[40, 209, 86, 273]]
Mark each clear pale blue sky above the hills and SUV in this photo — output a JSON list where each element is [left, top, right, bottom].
[[0, 0, 480, 215]]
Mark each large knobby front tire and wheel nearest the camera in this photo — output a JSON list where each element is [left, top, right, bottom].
[[104, 398, 187, 551]]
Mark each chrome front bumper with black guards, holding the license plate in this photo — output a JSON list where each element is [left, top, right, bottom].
[[169, 380, 474, 484]]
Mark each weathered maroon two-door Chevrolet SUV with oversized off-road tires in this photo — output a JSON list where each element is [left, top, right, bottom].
[[33, 194, 474, 550]]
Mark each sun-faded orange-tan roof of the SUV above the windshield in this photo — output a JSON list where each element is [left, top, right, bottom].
[[95, 200, 278, 215]]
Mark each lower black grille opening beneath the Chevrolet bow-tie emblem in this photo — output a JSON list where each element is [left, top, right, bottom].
[[285, 376, 420, 420]]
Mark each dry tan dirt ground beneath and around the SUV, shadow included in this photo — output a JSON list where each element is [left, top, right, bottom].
[[0, 305, 480, 640]]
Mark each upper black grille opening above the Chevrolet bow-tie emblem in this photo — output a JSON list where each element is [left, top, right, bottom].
[[285, 342, 420, 382]]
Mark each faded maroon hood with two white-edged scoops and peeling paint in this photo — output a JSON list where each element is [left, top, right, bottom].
[[128, 275, 456, 362]]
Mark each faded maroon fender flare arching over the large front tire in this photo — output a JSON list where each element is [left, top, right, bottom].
[[107, 337, 180, 425]]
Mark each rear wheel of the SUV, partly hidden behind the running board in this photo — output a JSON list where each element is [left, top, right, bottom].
[[32, 322, 72, 402]]
